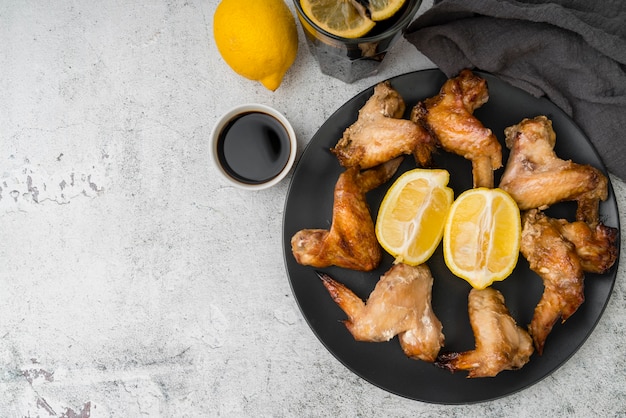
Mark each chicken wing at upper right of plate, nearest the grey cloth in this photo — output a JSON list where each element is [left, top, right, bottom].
[[499, 116, 608, 227]]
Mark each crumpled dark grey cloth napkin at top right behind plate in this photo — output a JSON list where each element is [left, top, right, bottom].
[[405, 0, 626, 180]]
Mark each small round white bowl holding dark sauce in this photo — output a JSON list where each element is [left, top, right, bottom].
[[210, 103, 298, 190]]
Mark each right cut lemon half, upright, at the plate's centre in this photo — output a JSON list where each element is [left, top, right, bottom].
[[443, 187, 522, 289]]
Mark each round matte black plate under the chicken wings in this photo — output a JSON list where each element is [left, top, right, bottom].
[[283, 70, 619, 404]]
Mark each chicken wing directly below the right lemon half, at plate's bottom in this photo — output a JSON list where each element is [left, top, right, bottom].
[[435, 287, 534, 378]]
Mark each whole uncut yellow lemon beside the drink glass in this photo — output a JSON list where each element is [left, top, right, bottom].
[[213, 0, 298, 91]]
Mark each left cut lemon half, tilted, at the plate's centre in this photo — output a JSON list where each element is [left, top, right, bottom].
[[376, 168, 454, 266]]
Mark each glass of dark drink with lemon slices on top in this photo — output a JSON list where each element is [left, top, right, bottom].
[[294, 0, 422, 83]]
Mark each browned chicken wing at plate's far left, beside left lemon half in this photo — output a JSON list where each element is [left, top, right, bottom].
[[291, 157, 402, 271]]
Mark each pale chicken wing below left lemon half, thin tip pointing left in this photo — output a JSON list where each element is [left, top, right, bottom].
[[319, 263, 444, 362]]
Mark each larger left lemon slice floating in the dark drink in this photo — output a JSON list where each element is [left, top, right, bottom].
[[300, 0, 375, 38]]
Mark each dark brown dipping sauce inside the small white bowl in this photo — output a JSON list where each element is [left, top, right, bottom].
[[217, 112, 291, 184]]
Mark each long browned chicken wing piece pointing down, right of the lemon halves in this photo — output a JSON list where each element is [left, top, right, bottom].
[[520, 209, 585, 354]]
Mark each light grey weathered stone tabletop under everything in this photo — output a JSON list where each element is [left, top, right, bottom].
[[0, 0, 626, 418]]
